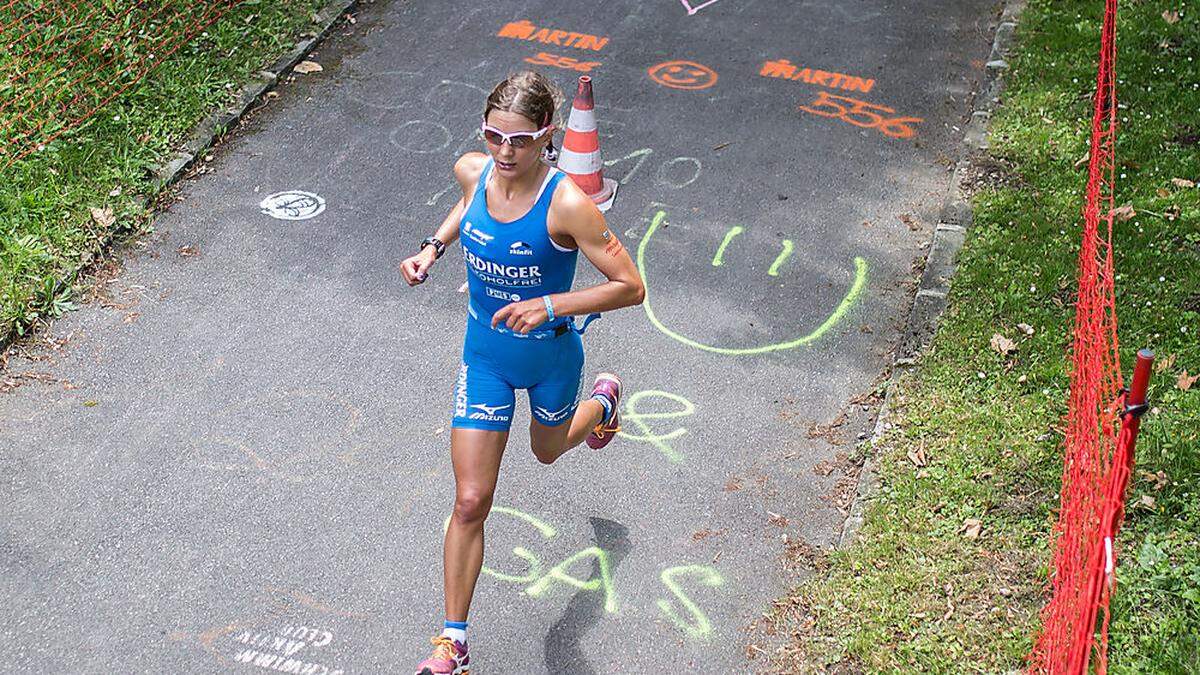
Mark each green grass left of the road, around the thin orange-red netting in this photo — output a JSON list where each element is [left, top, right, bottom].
[[0, 0, 324, 342]]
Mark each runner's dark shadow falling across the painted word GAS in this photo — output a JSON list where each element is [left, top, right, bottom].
[[545, 518, 632, 675]]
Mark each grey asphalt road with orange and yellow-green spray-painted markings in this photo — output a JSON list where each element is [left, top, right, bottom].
[[0, 0, 996, 674]]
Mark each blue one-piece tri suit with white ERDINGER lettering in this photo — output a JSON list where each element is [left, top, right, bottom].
[[452, 159, 583, 431]]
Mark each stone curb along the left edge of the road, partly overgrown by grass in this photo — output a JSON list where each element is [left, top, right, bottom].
[[0, 0, 359, 353]]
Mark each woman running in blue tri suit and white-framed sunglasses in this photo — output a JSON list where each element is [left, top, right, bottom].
[[400, 71, 646, 675]]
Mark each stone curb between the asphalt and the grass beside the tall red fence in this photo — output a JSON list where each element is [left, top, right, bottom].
[[838, 0, 1026, 548]]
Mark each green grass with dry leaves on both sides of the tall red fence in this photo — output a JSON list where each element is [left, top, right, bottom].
[[762, 0, 1200, 673]]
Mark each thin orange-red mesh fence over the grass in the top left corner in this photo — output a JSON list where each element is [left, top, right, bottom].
[[0, 0, 242, 172]]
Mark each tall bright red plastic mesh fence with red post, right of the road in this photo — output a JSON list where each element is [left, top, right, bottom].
[[1030, 0, 1133, 674]]
